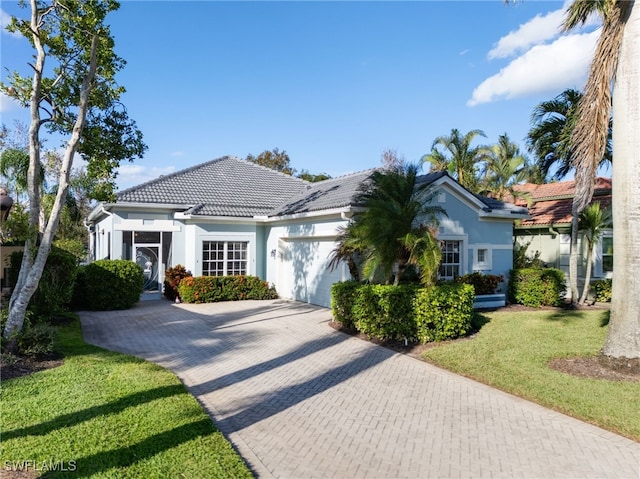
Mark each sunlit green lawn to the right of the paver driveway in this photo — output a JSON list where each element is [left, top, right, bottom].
[[424, 310, 640, 441]]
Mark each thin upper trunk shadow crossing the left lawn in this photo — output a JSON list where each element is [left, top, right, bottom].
[[2, 384, 184, 440]]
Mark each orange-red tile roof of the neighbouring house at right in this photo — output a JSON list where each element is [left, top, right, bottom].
[[514, 178, 611, 227]]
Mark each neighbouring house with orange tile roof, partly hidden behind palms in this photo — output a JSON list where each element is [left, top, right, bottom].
[[514, 178, 613, 281]]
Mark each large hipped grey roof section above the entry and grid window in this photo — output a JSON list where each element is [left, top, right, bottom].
[[117, 156, 310, 217]]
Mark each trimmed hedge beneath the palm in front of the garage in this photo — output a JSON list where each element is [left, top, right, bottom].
[[331, 281, 475, 343]]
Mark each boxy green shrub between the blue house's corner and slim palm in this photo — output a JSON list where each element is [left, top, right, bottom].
[[509, 268, 567, 308]]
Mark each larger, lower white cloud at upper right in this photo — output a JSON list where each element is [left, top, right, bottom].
[[467, 30, 600, 106]]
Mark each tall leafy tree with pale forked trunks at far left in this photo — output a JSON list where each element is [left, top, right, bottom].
[[0, 0, 146, 349]]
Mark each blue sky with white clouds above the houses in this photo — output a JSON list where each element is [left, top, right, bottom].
[[0, 0, 598, 188]]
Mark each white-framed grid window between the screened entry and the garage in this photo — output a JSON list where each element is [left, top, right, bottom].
[[202, 241, 249, 276]]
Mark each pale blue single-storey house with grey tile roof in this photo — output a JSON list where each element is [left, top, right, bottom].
[[88, 157, 528, 307]]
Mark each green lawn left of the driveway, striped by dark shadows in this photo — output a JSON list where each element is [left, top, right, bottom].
[[0, 321, 251, 479]]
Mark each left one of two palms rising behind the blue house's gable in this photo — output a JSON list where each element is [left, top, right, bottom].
[[422, 128, 491, 192]]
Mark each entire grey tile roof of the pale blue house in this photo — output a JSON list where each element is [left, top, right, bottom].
[[117, 156, 526, 218]]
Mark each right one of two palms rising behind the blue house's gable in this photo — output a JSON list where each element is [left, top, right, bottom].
[[479, 133, 528, 201]]
